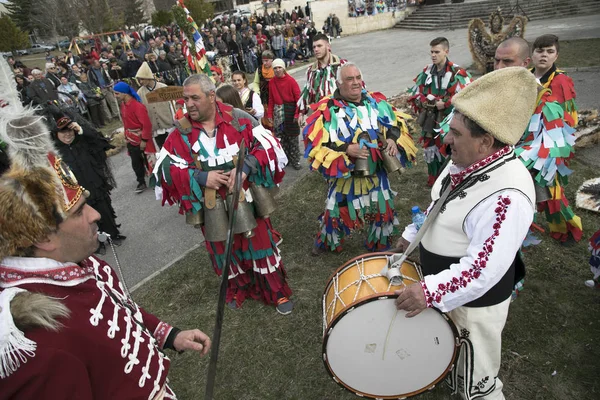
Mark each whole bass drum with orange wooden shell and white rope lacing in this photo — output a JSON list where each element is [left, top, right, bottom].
[[323, 253, 458, 399]]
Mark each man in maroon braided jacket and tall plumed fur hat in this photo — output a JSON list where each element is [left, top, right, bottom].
[[0, 73, 211, 400]]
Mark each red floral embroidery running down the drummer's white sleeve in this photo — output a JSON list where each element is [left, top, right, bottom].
[[421, 196, 510, 307]]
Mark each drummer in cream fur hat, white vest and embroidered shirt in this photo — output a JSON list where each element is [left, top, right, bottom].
[[396, 68, 537, 400]]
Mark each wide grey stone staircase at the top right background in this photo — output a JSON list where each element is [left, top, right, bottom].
[[395, 0, 600, 30]]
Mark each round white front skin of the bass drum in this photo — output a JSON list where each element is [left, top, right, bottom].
[[323, 296, 457, 399]]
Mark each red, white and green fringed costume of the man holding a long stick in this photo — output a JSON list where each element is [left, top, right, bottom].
[[154, 102, 291, 307]]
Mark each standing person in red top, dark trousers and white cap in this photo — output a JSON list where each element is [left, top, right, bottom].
[[267, 58, 302, 170]]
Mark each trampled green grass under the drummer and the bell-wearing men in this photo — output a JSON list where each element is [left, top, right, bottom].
[[134, 155, 600, 400]]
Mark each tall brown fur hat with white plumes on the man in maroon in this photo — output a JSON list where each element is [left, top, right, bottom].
[[0, 59, 85, 260]]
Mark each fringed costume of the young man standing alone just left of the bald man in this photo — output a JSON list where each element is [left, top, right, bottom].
[[408, 60, 471, 186]]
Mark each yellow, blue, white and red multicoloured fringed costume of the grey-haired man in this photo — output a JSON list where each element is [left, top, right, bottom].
[[303, 90, 417, 251]]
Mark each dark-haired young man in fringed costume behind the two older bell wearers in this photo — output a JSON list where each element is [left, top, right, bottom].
[[298, 33, 346, 120]]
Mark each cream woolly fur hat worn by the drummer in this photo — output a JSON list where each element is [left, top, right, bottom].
[[452, 67, 538, 145]]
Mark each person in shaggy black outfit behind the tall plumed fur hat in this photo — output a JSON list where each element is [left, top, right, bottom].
[[51, 114, 125, 253]]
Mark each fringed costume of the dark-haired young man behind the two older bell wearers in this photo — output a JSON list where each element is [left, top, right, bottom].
[[298, 53, 347, 114]]
